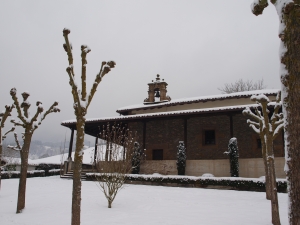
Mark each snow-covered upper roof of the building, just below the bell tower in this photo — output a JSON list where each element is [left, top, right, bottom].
[[117, 89, 279, 113]]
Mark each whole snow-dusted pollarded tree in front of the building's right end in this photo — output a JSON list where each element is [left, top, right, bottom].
[[243, 92, 284, 225]]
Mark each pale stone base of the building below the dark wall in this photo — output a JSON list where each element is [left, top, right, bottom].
[[140, 157, 286, 178]]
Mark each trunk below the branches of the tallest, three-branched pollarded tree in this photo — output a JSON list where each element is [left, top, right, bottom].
[[71, 116, 85, 225]]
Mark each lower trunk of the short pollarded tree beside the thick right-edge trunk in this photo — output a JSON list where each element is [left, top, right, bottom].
[[266, 139, 280, 225]]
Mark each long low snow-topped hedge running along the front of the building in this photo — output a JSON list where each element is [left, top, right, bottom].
[[86, 173, 287, 193]]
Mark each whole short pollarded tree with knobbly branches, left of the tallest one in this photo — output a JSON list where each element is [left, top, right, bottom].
[[8, 88, 60, 213]]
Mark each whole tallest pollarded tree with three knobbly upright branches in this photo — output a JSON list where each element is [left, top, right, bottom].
[[63, 28, 116, 225]]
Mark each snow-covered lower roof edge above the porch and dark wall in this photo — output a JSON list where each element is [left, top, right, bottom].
[[61, 102, 275, 127]]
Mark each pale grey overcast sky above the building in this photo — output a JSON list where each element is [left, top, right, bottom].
[[0, 0, 280, 142]]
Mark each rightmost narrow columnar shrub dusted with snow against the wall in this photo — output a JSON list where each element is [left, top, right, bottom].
[[224, 137, 239, 177]]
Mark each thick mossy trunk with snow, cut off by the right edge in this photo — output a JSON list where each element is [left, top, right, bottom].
[[280, 3, 300, 225]]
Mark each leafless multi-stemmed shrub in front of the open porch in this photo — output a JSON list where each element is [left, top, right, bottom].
[[95, 124, 142, 208]]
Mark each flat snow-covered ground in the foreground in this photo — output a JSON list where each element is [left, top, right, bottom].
[[0, 176, 288, 225]]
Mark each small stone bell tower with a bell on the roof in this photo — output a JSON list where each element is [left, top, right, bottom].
[[144, 74, 171, 105]]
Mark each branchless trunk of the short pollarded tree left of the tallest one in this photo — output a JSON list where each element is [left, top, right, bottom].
[[17, 133, 32, 213]]
